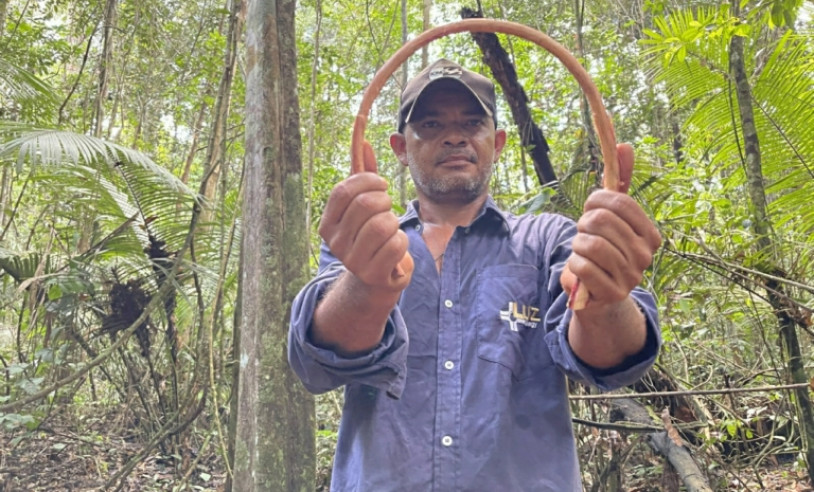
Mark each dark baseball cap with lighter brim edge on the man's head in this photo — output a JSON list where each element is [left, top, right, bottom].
[[398, 58, 497, 131]]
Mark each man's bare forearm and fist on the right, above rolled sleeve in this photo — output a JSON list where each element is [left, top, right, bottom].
[[561, 144, 661, 368]]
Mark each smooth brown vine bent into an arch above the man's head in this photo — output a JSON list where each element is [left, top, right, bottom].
[[351, 19, 619, 310]]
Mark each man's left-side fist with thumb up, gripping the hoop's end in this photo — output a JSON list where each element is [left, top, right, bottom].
[[319, 142, 413, 291]]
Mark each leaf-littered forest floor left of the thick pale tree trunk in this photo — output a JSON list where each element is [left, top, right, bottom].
[[0, 411, 226, 492]]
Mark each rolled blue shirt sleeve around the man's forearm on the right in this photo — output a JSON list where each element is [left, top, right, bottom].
[[546, 288, 661, 391]]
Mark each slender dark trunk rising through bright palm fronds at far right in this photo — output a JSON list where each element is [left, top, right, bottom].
[[729, 5, 814, 480]]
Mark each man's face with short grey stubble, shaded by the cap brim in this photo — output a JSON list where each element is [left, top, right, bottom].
[[390, 82, 506, 203]]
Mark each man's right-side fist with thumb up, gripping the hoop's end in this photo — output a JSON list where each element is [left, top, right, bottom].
[[560, 144, 661, 306]]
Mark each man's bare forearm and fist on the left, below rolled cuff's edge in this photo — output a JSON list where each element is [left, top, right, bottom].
[[310, 143, 413, 356]]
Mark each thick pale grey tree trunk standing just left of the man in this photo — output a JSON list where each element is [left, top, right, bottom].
[[232, 0, 316, 492]]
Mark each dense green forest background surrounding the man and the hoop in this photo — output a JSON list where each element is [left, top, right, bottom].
[[0, 0, 814, 491]]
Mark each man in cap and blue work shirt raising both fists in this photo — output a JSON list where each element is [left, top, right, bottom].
[[289, 60, 661, 492]]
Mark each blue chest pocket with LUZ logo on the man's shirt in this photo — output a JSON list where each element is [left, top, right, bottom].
[[475, 264, 551, 380]]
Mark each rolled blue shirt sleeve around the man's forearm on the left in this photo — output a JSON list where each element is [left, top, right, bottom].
[[288, 266, 407, 398]]
